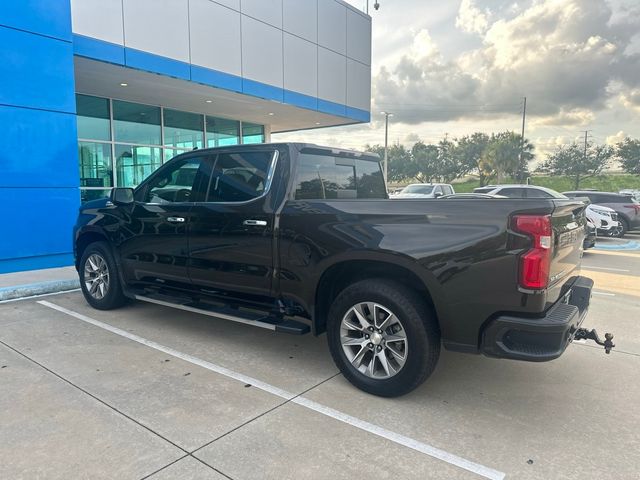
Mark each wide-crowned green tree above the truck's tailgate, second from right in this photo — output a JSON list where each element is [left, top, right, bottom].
[[538, 143, 615, 190]]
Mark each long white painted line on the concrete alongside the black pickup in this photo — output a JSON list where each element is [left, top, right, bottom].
[[38, 300, 505, 480]]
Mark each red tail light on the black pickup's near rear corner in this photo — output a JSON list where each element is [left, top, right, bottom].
[[513, 215, 553, 290]]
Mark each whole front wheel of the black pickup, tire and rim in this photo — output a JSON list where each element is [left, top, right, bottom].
[[79, 242, 127, 310]]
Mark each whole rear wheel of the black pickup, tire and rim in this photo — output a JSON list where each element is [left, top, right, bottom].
[[327, 279, 440, 397]]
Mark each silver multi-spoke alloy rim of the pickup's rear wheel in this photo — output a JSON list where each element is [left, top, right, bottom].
[[340, 302, 409, 380]]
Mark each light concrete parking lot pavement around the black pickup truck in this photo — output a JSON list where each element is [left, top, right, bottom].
[[0, 234, 640, 479]]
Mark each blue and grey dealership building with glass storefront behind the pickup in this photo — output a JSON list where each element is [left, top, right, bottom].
[[0, 0, 371, 273]]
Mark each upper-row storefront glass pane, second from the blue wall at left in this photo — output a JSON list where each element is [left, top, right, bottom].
[[113, 100, 160, 145]]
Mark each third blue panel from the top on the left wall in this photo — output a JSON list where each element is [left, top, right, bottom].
[[0, 106, 79, 188]]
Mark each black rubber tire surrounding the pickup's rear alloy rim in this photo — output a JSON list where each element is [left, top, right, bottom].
[[327, 279, 440, 397]]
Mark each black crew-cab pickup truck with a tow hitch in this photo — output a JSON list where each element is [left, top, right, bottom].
[[74, 143, 612, 396]]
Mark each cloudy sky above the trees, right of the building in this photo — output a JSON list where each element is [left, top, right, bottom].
[[273, 0, 640, 160]]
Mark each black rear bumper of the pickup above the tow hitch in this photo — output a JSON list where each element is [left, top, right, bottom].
[[481, 277, 593, 362]]
